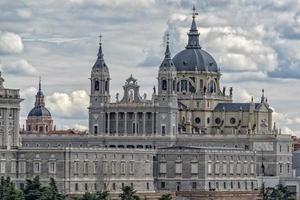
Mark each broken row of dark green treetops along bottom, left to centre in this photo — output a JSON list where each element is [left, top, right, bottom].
[[0, 176, 172, 200]]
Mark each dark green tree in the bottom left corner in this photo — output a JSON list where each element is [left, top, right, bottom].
[[0, 177, 24, 200]]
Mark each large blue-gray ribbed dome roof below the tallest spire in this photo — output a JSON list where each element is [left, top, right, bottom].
[[173, 48, 219, 72]]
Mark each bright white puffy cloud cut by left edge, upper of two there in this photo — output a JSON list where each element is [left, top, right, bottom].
[[0, 31, 23, 55]]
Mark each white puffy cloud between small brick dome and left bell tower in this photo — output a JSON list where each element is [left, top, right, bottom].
[[46, 90, 89, 118]]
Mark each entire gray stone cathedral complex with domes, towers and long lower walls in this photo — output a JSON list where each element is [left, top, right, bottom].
[[0, 7, 300, 199]]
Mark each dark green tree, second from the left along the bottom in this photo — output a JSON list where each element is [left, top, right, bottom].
[[23, 176, 43, 200]]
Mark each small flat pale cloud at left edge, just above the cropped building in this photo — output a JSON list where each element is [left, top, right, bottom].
[[0, 59, 37, 76]]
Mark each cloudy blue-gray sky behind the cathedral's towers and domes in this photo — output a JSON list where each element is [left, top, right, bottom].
[[0, 0, 300, 136]]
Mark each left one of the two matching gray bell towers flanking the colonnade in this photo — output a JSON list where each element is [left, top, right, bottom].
[[89, 35, 110, 135]]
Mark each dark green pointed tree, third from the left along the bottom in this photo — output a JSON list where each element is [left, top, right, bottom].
[[41, 178, 65, 200]]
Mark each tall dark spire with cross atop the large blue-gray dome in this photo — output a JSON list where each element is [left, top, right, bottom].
[[186, 5, 201, 49]]
